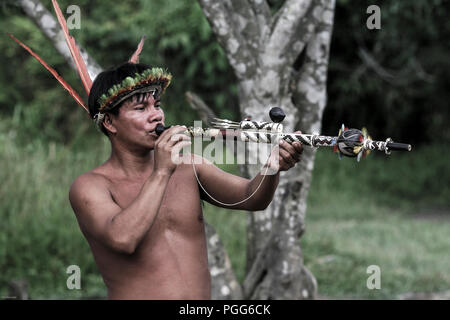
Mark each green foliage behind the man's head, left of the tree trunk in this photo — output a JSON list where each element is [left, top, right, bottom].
[[0, 0, 239, 142]]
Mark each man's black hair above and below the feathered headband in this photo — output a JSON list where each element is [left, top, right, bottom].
[[88, 62, 151, 135]]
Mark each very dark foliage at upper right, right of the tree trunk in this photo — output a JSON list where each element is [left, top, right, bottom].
[[323, 0, 450, 144]]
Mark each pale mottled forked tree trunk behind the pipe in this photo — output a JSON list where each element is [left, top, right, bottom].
[[199, 0, 334, 299]]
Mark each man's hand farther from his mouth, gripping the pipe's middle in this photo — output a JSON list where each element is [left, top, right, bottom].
[[266, 131, 303, 173]]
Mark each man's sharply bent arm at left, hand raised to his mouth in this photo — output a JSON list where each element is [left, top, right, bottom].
[[69, 126, 190, 254]]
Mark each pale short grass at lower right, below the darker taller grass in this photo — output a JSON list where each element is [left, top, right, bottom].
[[301, 208, 450, 298]]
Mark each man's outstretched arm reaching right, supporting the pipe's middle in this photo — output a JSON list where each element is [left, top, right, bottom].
[[196, 136, 303, 211]]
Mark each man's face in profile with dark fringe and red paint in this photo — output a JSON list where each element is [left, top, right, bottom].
[[113, 93, 164, 149]]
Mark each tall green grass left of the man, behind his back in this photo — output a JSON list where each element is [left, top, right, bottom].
[[0, 132, 109, 299]]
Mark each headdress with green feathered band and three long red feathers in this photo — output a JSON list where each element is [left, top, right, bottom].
[[8, 0, 172, 130]]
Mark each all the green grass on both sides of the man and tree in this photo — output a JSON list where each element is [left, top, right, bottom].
[[0, 131, 450, 299]]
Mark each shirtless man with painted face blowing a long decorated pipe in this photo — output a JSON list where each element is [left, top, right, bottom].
[[69, 64, 302, 299]]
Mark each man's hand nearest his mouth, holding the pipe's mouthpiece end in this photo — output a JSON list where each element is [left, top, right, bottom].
[[154, 126, 191, 175]]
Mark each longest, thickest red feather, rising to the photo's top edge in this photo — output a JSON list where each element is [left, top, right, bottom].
[[52, 0, 92, 94]]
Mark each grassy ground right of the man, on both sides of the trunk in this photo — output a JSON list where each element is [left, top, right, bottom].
[[206, 147, 450, 299]]
